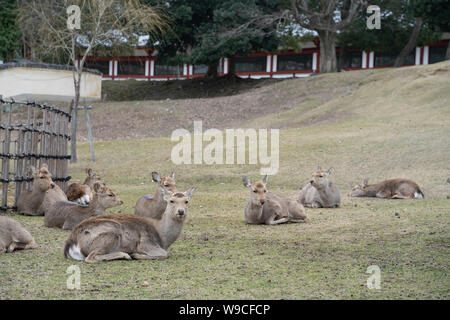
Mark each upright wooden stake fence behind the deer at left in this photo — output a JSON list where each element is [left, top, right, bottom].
[[0, 99, 71, 210]]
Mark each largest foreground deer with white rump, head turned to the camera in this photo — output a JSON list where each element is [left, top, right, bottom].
[[64, 187, 195, 263]]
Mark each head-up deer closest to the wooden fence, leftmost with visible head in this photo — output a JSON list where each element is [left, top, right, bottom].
[[16, 164, 56, 216]]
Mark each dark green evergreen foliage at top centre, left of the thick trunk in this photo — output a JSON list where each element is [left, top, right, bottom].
[[147, 0, 280, 69]]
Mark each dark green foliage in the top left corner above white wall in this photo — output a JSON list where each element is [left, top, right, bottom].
[[0, 0, 20, 60]]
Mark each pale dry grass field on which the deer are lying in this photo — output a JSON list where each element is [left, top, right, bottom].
[[0, 62, 450, 299]]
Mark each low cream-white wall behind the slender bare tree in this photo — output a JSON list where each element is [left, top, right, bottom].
[[0, 67, 102, 102]]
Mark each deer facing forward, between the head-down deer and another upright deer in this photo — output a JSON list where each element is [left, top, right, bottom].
[[298, 166, 341, 208]]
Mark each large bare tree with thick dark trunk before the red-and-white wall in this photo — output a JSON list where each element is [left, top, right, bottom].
[[290, 0, 367, 73]]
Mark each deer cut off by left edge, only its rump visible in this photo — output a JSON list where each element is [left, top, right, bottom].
[[0, 216, 38, 253]]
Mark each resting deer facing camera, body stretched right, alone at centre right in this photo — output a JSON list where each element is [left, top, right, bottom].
[[242, 175, 308, 225]]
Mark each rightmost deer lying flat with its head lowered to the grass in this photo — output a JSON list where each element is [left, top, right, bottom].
[[349, 179, 425, 199]]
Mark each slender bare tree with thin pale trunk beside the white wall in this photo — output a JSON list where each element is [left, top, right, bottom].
[[20, 0, 167, 162]]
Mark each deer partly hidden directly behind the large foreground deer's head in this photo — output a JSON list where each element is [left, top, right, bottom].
[[134, 171, 178, 219]]
